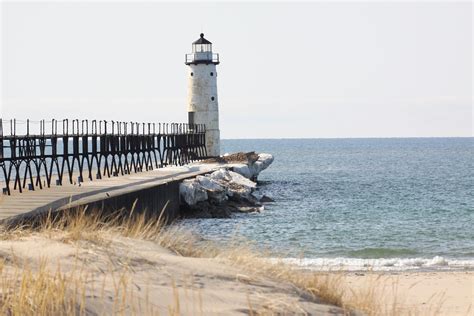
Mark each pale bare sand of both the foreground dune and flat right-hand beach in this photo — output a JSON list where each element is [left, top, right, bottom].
[[0, 226, 474, 315]]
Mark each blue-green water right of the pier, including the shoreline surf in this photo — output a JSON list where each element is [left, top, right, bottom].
[[180, 138, 474, 269]]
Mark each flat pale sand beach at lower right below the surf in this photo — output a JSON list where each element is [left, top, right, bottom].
[[343, 271, 474, 315]]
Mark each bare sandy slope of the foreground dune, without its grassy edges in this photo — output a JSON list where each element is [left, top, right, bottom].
[[0, 234, 343, 315]]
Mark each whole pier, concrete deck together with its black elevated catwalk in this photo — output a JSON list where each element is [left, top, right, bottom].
[[0, 119, 213, 222]]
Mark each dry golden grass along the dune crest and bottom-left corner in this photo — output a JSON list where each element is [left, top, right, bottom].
[[0, 208, 448, 315]]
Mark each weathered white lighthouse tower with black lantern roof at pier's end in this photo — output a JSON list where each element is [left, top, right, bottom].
[[185, 33, 220, 157]]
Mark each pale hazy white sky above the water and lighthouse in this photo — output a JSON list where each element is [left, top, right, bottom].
[[0, 1, 474, 138]]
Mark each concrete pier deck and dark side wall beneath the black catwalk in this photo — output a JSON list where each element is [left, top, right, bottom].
[[0, 164, 222, 222]]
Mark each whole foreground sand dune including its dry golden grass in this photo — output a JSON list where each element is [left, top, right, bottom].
[[0, 209, 472, 315]]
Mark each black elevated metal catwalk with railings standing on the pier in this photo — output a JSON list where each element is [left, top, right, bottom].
[[0, 119, 207, 194]]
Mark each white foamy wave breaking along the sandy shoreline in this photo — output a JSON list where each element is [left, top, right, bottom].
[[271, 256, 474, 271]]
